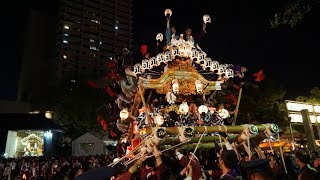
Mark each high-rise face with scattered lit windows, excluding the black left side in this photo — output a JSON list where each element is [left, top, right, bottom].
[[55, 0, 132, 80]]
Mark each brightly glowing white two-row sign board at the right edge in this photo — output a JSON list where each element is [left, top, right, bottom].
[[286, 100, 320, 123]]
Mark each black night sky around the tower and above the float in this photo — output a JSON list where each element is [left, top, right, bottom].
[[0, 0, 320, 100]]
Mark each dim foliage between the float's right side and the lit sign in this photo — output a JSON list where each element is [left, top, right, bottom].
[[237, 79, 289, 128]]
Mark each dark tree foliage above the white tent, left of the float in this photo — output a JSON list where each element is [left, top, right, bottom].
[[51, 79, 105, 138]]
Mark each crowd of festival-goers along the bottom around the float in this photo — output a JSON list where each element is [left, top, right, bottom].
[[0, 145, 320, 180]]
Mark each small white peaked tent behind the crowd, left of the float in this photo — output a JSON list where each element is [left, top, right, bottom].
[[72, 132, 105, 156]]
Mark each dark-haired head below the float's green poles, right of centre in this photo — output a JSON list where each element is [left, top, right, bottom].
[[219, 149, 238, 169]]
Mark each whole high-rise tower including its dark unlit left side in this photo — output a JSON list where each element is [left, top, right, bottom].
[[17, 0, 132, 103]]
